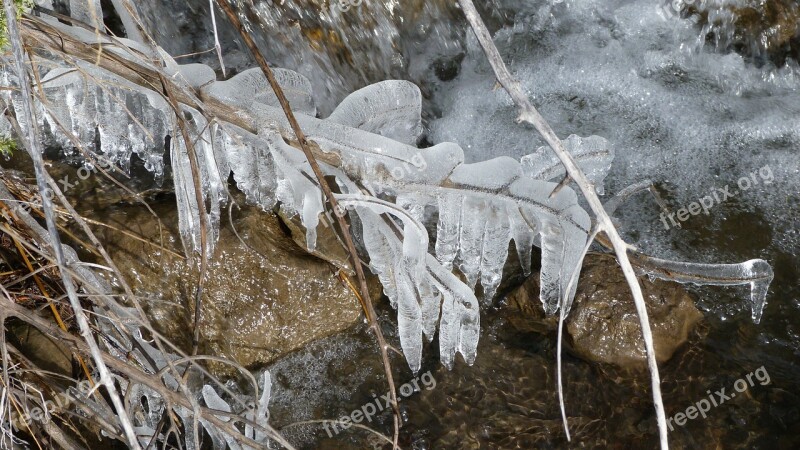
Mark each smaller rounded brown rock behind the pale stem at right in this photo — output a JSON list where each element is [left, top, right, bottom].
[[508, 255, 703, 368]]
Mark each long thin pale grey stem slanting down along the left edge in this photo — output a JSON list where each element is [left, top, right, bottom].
[[3, 0, 141, 449]]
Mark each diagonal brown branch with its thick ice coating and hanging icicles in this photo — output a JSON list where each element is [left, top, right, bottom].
[[3, 10, 770, 450]]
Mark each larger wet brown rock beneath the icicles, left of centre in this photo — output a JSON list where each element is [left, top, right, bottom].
[[95, 200, 368, 373]]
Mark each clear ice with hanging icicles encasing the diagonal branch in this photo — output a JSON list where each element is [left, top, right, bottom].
[[4, 11, 771, 376]]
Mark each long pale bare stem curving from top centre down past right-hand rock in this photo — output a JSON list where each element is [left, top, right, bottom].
[[458, 0, 669, 449]]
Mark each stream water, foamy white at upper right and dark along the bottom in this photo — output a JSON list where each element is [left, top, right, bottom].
[[131, 0, 800, 449]]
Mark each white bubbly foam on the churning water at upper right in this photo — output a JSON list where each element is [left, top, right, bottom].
[[429, 0, 800, 261]]
